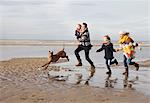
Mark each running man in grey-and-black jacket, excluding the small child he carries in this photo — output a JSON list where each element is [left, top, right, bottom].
[[75, 23, 95, 68]]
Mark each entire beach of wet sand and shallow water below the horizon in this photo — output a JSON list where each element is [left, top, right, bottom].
[[0, 41, 150, 103]]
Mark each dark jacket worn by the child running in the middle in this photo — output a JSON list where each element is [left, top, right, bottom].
[[96, 43, 116, 59]]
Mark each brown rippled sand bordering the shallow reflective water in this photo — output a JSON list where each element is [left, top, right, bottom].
[[0, 58, 150, 103]]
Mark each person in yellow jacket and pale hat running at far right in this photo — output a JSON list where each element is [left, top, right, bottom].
[[117, 32, 139, 75]]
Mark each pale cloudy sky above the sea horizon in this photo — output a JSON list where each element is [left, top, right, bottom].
[[0, 0, 150, 41]]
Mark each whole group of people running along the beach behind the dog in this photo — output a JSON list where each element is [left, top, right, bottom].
[[75, 23, 139, 76]]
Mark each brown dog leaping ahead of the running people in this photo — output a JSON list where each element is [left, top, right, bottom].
[[42, 48, 69, 69]]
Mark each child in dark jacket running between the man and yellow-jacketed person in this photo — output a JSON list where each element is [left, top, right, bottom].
[[96, 35, 118, 74]]
